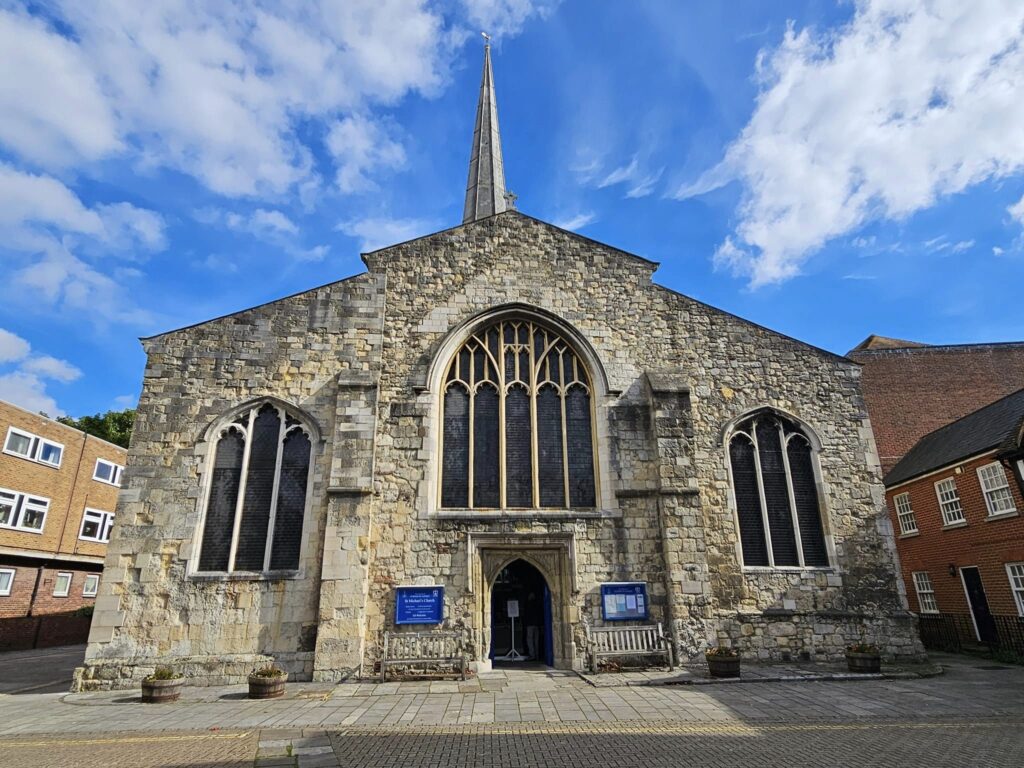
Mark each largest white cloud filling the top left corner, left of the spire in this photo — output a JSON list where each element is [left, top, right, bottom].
[[0, 0, 456, 196]]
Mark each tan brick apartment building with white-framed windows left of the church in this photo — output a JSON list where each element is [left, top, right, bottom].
[[0, 401, 127, 620]]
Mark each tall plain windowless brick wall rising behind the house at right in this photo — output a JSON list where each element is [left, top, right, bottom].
[[848, 342, 1024, 472]]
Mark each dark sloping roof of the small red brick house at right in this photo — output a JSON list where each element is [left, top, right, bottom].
[[885, 389, 1024, 487]]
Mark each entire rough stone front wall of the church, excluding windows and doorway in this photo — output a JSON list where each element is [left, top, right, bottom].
[[77, 212, 921, 688]]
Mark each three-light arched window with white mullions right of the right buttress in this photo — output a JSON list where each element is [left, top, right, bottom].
[[729, 412, 828, 567]]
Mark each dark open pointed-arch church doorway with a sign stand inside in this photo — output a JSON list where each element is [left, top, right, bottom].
[[490, 560, 554, 667]]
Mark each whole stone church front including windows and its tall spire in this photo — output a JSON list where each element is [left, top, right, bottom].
[[77, 46, 922, 688]]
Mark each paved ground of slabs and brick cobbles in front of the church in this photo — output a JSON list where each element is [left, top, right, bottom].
[[0, 656, 1024, 768]]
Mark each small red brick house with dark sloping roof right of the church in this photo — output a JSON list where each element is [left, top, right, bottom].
[[885, 389, 1024, 655]]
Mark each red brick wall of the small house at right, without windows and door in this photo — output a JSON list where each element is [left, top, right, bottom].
[[886, 455, 1024, 615]]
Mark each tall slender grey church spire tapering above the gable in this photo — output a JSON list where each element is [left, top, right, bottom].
[[462, 33, 508, 224]]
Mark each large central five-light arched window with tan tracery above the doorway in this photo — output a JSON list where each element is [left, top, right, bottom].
[[440, 319, 597, 509]]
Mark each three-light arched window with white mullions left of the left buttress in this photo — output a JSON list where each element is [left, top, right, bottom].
[[198, 400, 313, 572]]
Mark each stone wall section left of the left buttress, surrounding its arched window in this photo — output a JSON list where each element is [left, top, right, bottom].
[[77, 274, 382, 688]]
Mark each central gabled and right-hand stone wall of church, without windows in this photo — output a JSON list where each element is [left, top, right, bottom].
[[367, 212, 920, 664]]
